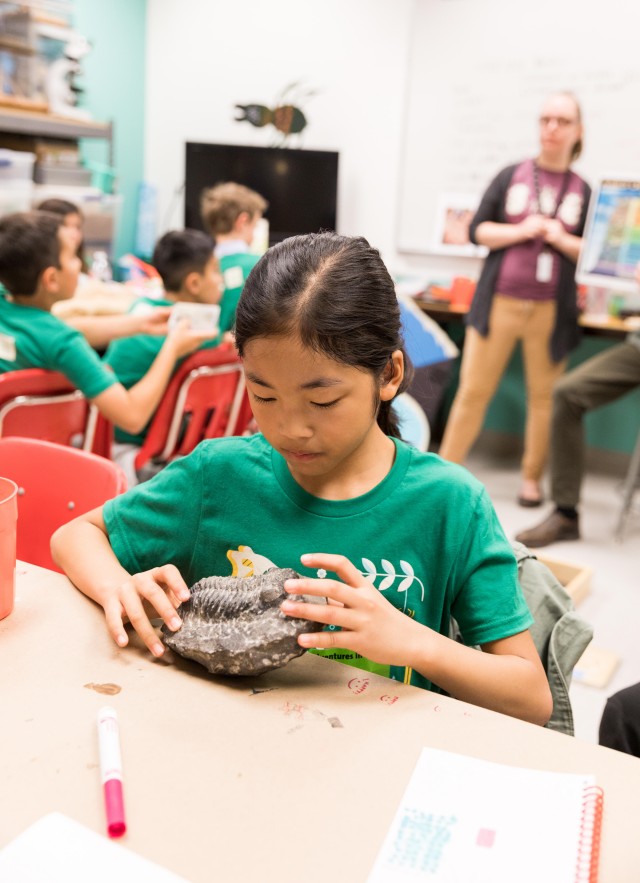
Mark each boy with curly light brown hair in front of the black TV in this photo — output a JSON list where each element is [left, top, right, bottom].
[[200, 181, 269, 331]]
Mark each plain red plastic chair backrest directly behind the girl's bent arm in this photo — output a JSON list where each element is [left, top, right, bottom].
[[0, 437, 127, 570]]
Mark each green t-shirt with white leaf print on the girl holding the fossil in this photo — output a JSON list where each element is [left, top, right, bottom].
[[104, 435, 533, 687]]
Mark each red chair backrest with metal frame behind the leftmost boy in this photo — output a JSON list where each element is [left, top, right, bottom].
[[0, 368, 113, 457]]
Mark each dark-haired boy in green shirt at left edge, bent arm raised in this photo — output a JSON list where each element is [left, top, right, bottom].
[[0, 211, 213, 446]]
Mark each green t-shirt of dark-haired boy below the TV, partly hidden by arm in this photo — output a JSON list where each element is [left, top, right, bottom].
[[103, 297, 220, 445]]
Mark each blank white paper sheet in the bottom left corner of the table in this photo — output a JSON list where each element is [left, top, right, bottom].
[[0, 812, 188, 883]]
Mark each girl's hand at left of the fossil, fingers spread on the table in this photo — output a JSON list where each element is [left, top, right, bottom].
[[102, 564, 190, 656]]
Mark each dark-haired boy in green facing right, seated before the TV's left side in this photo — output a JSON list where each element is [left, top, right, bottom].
[[104, 230, 222, 446]]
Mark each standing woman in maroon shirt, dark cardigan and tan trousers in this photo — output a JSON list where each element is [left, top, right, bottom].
[[440, 92, 591, 506]]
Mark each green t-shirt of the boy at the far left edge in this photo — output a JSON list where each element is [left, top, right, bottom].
[[0, 297, 117, 399]]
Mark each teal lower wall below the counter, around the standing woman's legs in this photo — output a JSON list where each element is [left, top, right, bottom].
[[442, 322, 640, 454]]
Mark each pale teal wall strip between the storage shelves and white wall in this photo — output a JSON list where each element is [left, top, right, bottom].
[[73, 0, 147, 258]]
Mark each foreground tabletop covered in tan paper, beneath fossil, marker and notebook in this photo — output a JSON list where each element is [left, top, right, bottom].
[[0, 562, 640, 883]]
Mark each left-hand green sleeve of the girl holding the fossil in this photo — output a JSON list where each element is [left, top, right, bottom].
[[103, 448, 203, 576]]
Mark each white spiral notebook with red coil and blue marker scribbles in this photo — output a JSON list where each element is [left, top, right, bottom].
[[367, 748, 603, 883]]
